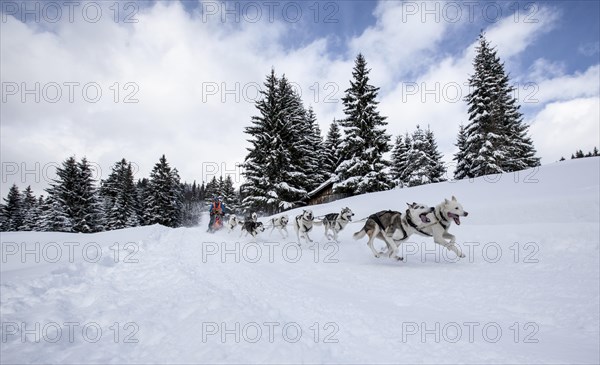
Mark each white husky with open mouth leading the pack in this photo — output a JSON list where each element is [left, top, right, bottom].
[[417, 196, 469, 258]]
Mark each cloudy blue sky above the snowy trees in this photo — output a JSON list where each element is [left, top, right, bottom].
[[0, 0, 600, 196]]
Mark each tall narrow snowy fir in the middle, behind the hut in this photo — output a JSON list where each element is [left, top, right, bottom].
[[334, 54, 392, 195]]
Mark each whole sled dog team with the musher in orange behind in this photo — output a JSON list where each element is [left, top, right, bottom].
[[209, 196, 469, 260]]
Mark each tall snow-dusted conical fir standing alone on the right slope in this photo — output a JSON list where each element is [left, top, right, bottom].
[[454, 33, 540, 179]]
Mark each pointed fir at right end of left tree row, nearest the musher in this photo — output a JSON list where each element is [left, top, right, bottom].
[[145, 155, 183, 228]]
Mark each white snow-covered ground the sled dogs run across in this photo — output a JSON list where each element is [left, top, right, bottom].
[[0, 158, 600, 364]]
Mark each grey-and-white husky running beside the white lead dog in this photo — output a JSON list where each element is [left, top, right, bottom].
[[353, 203, 434, 260]]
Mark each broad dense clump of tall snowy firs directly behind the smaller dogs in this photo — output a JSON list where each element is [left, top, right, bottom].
[[241, 69, 327, 214]]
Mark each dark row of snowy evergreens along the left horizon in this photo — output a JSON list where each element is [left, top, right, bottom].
[[0, 155, 239, 233]]
